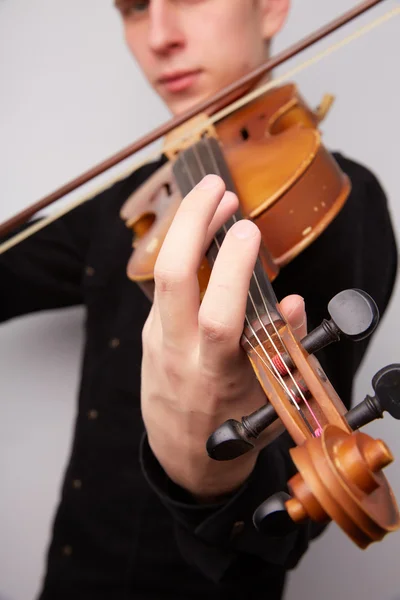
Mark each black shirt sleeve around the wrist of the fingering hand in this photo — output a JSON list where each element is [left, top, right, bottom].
[[140, 434, 324, 585]]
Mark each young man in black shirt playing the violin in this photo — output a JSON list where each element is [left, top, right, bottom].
[[0, 0, 396, 600]]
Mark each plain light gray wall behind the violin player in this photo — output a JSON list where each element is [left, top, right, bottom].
[[0, 0, 400, 600]]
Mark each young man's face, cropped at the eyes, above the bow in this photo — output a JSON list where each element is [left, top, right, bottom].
[[115, 0, 289, 114]]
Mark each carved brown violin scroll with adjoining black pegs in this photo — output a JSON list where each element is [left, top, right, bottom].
[[253, 364, 400, 549]]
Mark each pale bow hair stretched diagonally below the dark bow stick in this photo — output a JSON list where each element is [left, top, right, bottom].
[[0, 7, 400, 255]]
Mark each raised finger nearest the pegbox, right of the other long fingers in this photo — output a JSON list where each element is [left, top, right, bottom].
[[199, 220, 261, 372]]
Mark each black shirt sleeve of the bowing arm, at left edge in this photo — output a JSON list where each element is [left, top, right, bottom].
[[0, 164, 154, 322]]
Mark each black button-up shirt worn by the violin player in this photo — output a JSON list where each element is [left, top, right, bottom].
[[0, 155, 397, 600]]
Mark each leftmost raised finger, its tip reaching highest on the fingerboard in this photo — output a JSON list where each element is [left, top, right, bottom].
[[154, 175, 225, 345]]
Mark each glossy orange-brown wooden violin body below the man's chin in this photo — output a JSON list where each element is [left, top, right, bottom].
[[121, 84, 351, 290]]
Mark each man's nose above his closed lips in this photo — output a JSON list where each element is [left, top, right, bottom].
[[149, 0, 184, 54]]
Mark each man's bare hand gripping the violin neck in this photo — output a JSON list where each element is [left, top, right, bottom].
[[141, 175, 306, 501]]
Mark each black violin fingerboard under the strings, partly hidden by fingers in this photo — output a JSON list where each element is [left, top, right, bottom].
[[173, 137, 284, 330]]
